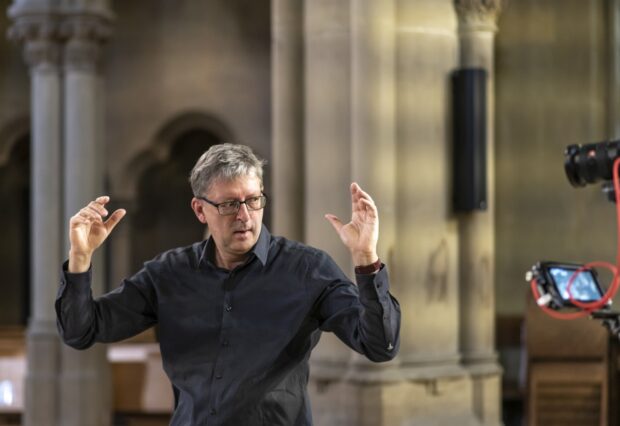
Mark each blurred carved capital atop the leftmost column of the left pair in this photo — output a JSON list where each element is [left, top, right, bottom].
[[8, 15, 60, 69]]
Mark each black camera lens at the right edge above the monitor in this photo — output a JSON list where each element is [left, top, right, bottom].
[[564, 141, 620, 186]]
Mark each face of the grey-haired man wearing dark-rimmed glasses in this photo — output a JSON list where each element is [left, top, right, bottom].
[[192, 175, 263, 260]]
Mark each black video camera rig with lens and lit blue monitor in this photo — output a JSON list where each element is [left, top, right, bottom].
[[525, 140, 620, 339]]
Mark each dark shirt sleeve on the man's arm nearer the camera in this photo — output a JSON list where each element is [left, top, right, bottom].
[[309, 253, 400, 362]]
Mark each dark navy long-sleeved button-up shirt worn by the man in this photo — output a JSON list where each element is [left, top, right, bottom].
[[56, 226, 400, 426]]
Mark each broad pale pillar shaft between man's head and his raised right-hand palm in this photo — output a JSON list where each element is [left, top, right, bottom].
[[304, 0, 352, 362]]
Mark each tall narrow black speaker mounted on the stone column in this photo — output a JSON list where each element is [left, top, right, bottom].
[[452, 68, 487, 212]]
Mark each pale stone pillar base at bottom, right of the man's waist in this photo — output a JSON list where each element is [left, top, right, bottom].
[[309, 374, 492, 426]]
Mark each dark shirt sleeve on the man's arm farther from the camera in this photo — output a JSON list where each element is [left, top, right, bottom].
[[55, 262, 157, 349]]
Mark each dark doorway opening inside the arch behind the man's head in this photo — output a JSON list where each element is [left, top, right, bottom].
[[131, 128, 221, 270]]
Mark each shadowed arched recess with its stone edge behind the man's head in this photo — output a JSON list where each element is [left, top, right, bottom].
[[120, 112, 233, 270]]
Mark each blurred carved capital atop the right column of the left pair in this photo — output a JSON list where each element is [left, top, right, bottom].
[[61, 15, 112, 71]]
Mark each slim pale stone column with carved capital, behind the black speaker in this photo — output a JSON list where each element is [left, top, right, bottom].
[[454, 0, 501, 425]]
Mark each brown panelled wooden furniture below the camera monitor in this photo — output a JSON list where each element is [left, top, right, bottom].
[[525, 298, 618, 426]]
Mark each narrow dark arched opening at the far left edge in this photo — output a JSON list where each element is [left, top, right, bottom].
[[0, 134, 31, 326]]
